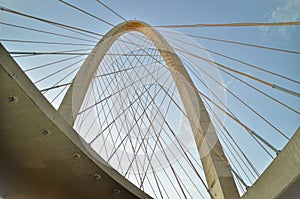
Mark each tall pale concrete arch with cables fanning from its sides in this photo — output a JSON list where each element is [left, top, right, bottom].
[[59, 20, 238, 198]]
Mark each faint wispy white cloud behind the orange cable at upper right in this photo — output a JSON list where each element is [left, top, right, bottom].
[[261, 0, 300, 41]]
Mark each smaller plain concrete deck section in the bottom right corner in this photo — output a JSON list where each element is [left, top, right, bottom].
[[242, 128, 300, 199]]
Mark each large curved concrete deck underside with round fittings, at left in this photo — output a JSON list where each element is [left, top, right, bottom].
[[0, 44, 142, 199]]
